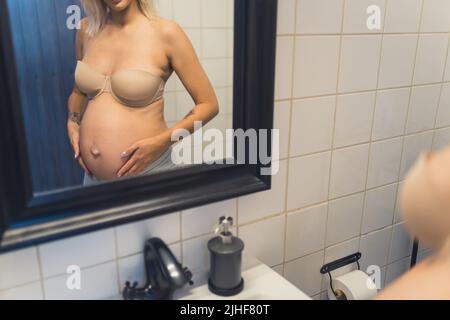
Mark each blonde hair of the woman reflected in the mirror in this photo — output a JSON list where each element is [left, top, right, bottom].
[[81, 0, 155, 37]]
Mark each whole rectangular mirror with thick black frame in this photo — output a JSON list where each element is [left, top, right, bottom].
[[0, 0, 277, 251]]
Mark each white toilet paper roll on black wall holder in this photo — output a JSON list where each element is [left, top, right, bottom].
[[328, 270, 378, 300]]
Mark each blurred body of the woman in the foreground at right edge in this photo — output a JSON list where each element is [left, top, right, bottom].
[[377, 147, 450, 300]]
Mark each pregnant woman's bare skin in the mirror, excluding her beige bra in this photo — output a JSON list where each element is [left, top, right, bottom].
[[67, 0, 218, 181]]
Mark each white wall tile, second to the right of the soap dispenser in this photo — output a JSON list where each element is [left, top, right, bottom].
[[285, 204, 328, 260]]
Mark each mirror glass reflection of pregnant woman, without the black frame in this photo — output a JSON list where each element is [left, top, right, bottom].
[[8, 0, 234, 192]]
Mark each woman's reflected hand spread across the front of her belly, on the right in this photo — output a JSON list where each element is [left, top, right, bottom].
[[117, 134, 170, 178]]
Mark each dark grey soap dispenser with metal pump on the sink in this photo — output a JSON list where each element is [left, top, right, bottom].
[[208, 216, 244, 296]]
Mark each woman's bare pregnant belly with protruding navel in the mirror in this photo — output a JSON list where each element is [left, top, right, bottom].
[[80, 94, 167, 181]]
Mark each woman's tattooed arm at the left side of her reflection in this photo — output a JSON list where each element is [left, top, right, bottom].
[[67, 21, 92, 175]]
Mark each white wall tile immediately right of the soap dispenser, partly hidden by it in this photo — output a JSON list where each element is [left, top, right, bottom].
[[239, 215, 286, 266]]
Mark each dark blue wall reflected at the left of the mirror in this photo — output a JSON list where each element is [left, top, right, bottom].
[[7, 0, 82, 192]]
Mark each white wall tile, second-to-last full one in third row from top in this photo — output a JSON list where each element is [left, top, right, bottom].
[[372, 88, 411, 140]]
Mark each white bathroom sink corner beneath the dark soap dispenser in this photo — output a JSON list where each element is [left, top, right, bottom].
[[174, 256, 311, 300]]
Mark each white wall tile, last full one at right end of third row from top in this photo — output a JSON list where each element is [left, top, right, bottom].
[[406, 84, 441, 134]]
